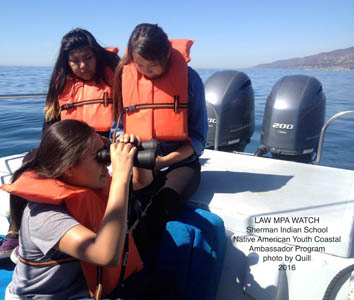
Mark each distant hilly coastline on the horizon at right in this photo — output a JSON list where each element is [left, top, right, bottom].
[[252, 47, 354, 71]]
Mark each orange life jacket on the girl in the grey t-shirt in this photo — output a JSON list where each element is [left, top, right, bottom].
[[0, 171, 143, 296]]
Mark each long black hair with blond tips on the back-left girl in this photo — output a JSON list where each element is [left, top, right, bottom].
[[45, 28, 119, 122]]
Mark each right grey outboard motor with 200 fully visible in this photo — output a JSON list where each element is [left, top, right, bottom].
[[255, 75, 326, 163]]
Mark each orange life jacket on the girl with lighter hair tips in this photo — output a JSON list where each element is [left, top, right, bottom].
[[58, 48, 118, 131]]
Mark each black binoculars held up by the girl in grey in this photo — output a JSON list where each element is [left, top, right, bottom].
[[97, 140, 159, 170]]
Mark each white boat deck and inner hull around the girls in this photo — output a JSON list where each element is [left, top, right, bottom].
[[0, 150, 354, 300]]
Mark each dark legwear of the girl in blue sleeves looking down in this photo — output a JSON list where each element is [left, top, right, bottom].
[[133, 160, 200, 263]]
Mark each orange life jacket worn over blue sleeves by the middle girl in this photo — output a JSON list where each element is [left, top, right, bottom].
[[122, 39, 193, 141]]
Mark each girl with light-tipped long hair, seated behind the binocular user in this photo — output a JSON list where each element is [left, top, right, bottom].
[[0, 28, 119, 258]]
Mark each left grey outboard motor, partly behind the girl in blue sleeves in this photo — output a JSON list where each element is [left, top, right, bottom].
[[205, 71, 255, 152]]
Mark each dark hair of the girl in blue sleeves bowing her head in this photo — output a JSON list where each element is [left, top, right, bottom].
[[113, 23, 171, 119]]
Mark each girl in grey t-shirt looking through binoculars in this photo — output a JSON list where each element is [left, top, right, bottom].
[[1, 120, 150, 299]]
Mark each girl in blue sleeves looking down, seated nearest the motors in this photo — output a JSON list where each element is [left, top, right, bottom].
[[112, 24, 208, 256]]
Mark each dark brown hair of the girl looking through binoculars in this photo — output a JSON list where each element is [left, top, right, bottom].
[[12, 119, 95, 182]]
